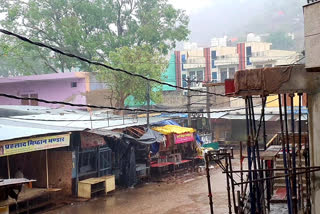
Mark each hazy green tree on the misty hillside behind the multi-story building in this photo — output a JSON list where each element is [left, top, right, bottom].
[[266, 31, 295, 50]]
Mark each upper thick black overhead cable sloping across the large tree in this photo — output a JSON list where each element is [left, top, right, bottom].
[[0, 28, 227, 97]]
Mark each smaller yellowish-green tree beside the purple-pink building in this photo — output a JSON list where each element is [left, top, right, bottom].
[[96, 45, 168, 107]]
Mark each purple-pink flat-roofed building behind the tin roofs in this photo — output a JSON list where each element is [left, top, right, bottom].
[[0, 72, 91, 108]]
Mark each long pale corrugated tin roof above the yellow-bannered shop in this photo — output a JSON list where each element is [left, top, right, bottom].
[[0, 106, 168, 141]]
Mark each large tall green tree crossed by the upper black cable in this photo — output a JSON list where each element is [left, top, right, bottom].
[[0, 0, 189, 74]]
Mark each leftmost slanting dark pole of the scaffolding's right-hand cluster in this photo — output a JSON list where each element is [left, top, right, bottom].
[[278, 94, 292, 214]]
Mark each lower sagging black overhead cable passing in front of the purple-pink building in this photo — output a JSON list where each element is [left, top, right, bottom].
[[0, 93, 278, 114]]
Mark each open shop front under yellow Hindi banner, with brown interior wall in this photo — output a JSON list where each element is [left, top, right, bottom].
[[0, 133, 72, 211]]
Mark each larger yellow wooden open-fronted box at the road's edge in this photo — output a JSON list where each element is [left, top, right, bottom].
[[78, 178, 107, 198]]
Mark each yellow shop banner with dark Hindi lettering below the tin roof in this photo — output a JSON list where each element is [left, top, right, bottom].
[[0, 134, 70, 157]]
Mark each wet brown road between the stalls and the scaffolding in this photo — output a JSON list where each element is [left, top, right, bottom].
[[47, 159, 239, 214]]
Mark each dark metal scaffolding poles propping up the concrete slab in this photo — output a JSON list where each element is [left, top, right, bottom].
[[205, 93, 320, 214]]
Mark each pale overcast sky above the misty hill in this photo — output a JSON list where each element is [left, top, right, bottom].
[[169, 0, 306, 46]]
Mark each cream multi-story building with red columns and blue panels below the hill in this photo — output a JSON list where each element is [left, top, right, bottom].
[[175, 36, 301, 87]]
